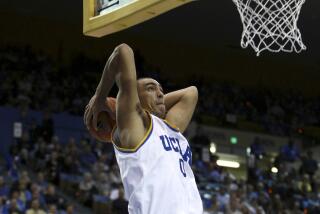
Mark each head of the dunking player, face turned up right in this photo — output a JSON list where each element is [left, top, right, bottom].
[[138, 78, 166, 118]]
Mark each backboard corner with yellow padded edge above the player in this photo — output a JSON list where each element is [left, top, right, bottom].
[[83, 0, 194, 37]]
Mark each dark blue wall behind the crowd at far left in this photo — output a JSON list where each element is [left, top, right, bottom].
[[0, 107, 87, 156]]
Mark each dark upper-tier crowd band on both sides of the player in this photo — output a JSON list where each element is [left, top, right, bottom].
[[0, 46, 320, 136]]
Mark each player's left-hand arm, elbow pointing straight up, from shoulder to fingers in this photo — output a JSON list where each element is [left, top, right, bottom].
[[85, 44, 148, 148]]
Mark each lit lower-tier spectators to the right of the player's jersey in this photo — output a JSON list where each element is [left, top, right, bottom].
[[193, 135, 320, 214]]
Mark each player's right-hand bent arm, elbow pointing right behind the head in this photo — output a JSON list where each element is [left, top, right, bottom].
[[164, 86, 198, 132]]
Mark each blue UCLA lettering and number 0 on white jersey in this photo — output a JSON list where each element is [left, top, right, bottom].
[[160, 135, 192, 177]]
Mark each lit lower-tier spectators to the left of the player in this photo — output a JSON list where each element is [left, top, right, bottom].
[[0, 107, 127, 214]]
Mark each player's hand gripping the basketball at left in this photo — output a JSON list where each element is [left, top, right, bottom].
[[83, 95, 115, 131]]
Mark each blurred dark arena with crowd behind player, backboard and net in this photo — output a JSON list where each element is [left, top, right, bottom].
[[0, 0, 320, 213]]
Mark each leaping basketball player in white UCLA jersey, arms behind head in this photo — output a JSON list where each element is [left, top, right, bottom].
[[84, 44, 203, 214]]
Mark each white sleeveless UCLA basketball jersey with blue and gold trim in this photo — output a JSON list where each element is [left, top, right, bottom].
[[113, 115, 203, 214]]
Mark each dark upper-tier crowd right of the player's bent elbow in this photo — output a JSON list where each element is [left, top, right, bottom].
[[199, 83, 320, 136]]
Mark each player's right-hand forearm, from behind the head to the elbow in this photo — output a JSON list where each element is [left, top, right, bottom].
[[164, 86, 198, 111]]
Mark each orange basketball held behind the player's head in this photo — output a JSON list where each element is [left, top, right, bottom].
[[89, 97, 116, 142]]
